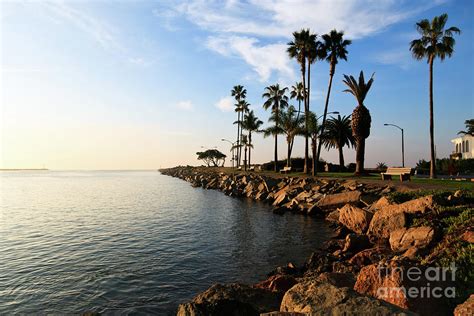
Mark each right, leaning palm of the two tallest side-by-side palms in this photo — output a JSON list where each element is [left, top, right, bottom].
[[316, 30, 352, 174]]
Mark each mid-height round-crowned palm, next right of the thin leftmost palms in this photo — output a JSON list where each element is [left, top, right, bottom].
[[262, 84, 288, 172]]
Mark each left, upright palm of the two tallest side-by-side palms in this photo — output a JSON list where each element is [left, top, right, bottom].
[[287, 29, 316, 173]]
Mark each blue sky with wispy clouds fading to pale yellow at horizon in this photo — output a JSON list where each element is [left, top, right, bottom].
[[0, 0, 474, 170]]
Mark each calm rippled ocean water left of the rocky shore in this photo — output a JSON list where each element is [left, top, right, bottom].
[[0, 171, 330, 315]]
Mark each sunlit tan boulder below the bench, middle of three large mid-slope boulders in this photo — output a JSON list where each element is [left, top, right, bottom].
[[367, 206, 407, 239]]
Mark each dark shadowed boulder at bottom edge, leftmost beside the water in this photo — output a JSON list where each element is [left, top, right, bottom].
[[177, 283, 281, 316]]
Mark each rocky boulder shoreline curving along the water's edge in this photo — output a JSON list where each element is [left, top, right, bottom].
[[160, 167, 474, 315]]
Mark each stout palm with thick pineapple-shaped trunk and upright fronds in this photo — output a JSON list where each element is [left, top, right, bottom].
[[343, 71, 374, 175]]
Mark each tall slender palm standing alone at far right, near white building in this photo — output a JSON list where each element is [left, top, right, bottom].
[[410, 13, 461, 178]]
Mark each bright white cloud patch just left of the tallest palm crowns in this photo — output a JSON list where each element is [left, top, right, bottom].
[[206, 36, 295, 81]]
